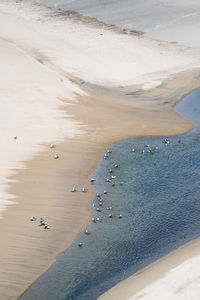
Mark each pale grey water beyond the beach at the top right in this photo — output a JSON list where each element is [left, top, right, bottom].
[[35, 0, 200, 48]]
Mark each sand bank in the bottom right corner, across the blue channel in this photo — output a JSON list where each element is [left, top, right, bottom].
[[98, 239, 200, 300]]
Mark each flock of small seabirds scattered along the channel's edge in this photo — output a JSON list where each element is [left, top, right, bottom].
[[28, 136, 173, 247]]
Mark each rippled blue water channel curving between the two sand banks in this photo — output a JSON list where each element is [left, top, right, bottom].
[[21, 91, 200, 300]]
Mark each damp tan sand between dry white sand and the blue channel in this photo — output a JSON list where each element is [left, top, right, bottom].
[[0, 69, 200, 299]]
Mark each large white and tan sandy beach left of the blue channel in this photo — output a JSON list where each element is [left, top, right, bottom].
[[0, 1, 200, 299]]
